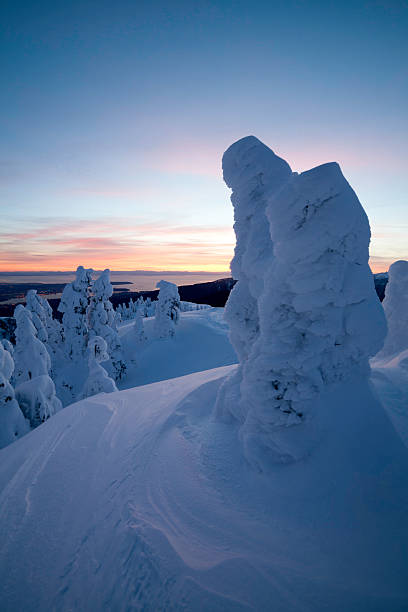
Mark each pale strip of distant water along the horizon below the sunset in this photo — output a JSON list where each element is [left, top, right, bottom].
[[0, 271, 231, 302]]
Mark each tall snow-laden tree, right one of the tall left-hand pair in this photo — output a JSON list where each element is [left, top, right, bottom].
[[88, 270, 126, 380]]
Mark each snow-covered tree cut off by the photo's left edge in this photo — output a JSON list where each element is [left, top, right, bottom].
[[0, 342, 29, 448]]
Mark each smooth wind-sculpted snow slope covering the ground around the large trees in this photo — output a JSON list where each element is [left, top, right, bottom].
[[0, 309, 408, 612]]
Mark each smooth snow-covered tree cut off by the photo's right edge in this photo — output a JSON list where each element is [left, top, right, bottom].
[[376, 260, 408, 359]]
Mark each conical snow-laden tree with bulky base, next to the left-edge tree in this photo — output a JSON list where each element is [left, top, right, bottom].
[[14, 304, 62, 427]]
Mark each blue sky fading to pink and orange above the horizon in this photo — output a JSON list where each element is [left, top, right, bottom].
[[0, 0, 408, 271]]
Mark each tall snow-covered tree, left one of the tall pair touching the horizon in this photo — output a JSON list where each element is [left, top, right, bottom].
[[58, 266, 92, 362]]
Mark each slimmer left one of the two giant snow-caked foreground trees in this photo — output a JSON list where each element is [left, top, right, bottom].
[[218, 136, 292, 419]]
